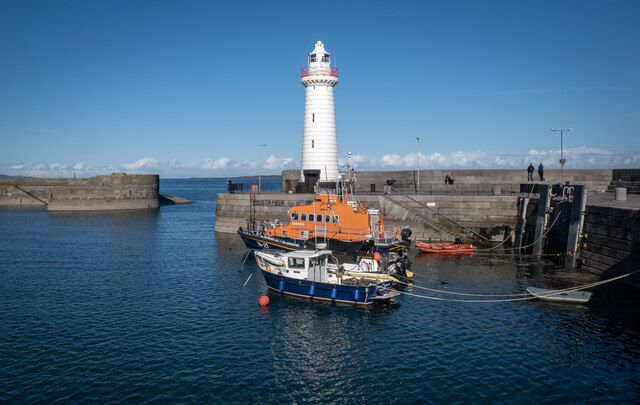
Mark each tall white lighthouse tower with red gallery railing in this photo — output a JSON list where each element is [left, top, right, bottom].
[[300, 41, 338, 181]]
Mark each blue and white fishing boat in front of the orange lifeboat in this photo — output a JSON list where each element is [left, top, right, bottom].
[[253, 250, 400, 305]]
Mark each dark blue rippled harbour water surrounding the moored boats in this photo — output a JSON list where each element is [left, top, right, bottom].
[[0, 179, 640, 404]]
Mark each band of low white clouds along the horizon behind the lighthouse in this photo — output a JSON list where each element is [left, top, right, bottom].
[[0, 146, 640, 178]]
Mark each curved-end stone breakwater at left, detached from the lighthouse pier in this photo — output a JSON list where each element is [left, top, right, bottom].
[[0, 173, 159, 211]]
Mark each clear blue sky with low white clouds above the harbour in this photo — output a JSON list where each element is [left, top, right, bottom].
[[0, 0, 640, 178]]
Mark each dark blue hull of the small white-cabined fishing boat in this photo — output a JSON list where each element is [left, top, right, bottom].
[[262, 270, 398, 305]]
